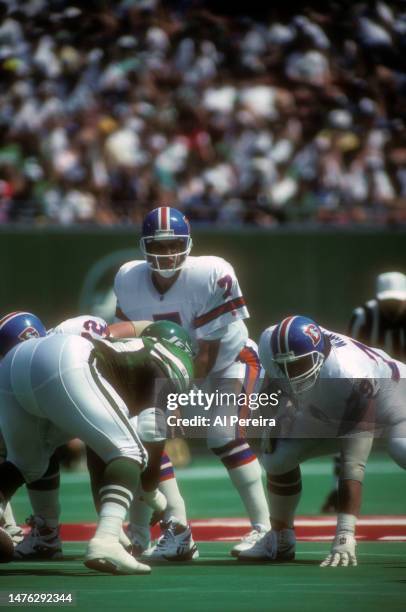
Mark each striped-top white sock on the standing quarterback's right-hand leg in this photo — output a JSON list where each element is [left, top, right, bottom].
[[212, 439, 270, 529]]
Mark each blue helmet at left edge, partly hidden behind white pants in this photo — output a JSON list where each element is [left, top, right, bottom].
[[0, 311, 47, 355]]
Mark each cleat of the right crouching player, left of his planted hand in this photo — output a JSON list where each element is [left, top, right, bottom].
[[238, 529, 296, 562]]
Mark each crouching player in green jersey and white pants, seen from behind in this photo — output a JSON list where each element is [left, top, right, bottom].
[[0, 314, 192, 574]]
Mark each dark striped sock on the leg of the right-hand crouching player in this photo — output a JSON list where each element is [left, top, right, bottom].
[[268, 466, 302, 529]]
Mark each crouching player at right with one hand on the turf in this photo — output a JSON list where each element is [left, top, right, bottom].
[[240, 316, 406, 567]]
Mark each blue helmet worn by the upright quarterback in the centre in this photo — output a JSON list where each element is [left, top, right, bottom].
[[140, 206, 192, 278]]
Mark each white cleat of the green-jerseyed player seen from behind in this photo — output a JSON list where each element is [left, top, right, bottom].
[[84, 538, 151, 574]]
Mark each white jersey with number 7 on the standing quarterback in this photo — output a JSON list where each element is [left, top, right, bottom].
[[114, 256, 249, 372]]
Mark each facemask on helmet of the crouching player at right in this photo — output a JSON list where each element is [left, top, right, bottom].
[[273, 351, 325, 394]]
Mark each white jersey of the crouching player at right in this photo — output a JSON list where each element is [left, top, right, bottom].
[[259, 325, 406, 437]]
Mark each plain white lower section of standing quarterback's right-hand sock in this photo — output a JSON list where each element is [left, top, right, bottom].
[[228, 459, 271, 530]]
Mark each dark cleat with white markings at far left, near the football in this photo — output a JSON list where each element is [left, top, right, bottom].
[[14, 516, 62, 561]]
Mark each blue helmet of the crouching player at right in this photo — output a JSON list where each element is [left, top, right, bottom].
[[271, 316, 326, 393]]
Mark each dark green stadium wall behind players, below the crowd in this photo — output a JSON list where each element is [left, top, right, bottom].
[[0, 228, 406, 338]]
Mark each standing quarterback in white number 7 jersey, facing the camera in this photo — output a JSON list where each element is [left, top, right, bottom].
[[114, 206, 270, 558]]
